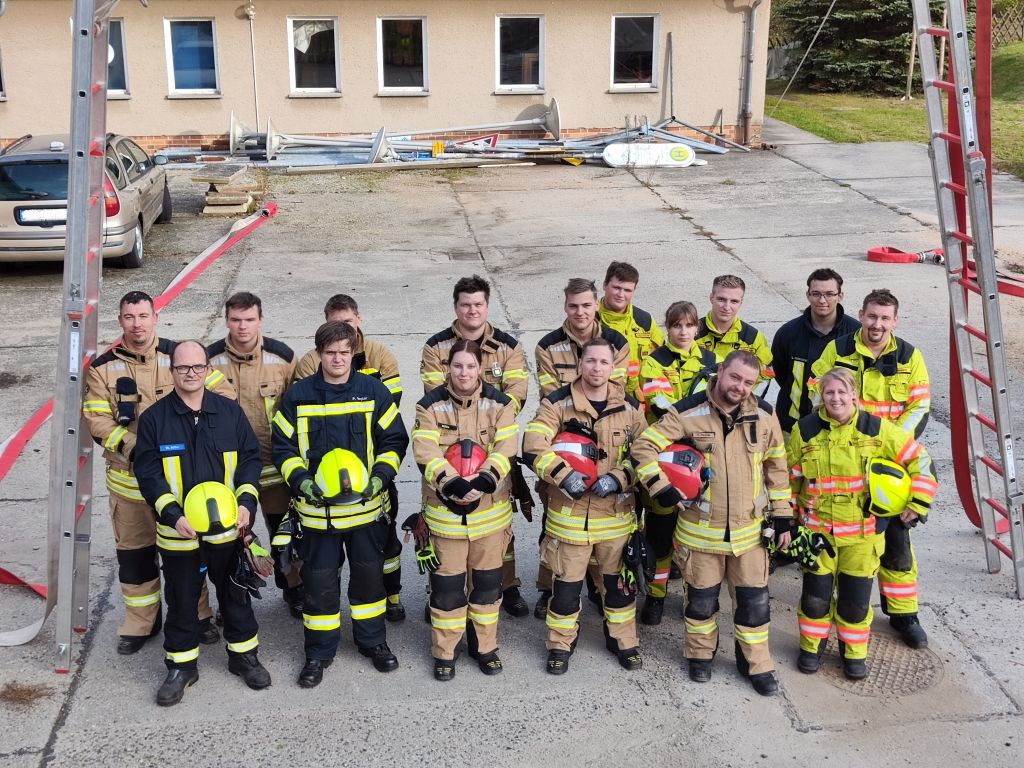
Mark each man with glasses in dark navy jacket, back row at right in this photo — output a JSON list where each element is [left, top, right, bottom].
[[771, 267, 860, 435]]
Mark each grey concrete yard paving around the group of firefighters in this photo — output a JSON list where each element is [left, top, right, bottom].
[[0, 124, 1024, 768]]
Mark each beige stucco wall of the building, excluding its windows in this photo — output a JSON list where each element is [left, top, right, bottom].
[[0, 0, 769, 144]]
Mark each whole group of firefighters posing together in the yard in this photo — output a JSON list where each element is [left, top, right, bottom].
[[83, 261, 937, 707]]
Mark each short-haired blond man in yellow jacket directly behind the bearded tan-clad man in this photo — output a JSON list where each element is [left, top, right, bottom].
[[697, 274, 775, 392]]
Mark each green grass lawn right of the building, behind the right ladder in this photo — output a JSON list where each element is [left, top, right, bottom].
[[765, 43, 1024, 178]]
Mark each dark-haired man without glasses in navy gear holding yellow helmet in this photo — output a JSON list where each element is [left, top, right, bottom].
[[271, 323, 409, 688]]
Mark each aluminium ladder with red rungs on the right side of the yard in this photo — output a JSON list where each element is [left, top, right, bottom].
[[911, 0, 1024, 599]]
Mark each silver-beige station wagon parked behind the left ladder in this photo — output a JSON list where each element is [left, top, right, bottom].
[[0, 133, 171, 267]]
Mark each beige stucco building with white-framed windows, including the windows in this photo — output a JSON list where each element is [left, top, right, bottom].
[[0, 0, 769, 148]]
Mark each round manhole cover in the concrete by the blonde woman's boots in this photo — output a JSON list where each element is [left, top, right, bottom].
[[819, 632, 942, 696]]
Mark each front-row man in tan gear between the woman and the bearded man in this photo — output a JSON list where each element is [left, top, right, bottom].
[[522, 338, 646, 675]]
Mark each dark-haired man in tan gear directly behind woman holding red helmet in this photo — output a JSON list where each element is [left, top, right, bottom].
[[420, 274, 534, 616]]
